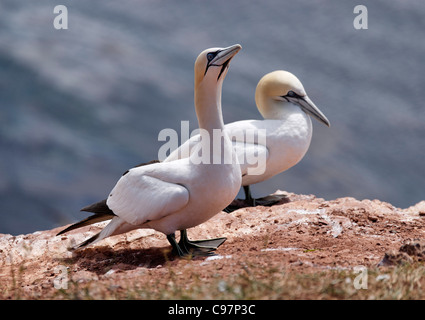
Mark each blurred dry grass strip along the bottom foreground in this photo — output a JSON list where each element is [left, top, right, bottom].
[[0, 264, 425, 300]]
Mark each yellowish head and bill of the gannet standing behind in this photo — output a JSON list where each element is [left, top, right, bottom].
[[255, 70, 330, 127]]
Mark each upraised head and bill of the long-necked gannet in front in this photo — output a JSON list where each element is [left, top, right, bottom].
[[195, 44, 242, 85]]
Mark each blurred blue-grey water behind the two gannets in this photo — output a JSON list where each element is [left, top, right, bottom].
[[0, 0, 425, 234]]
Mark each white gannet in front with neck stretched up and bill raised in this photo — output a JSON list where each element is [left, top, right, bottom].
[[58, 44, 242, 256]]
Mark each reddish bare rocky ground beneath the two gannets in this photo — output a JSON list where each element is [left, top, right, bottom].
[[0, 191, 425, 297]]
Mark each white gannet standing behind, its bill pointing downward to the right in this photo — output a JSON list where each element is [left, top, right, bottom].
[[164, 70, 330, 212]]
